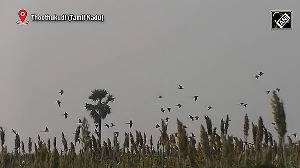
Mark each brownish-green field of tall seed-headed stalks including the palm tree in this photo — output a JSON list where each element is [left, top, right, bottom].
[[0, 90, 300, 168]]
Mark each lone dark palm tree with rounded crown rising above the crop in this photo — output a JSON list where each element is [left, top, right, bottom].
[[85, 89, 115, 145]]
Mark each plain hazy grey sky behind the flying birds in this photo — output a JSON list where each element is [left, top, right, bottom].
[[0, 0, 300, 149]]
